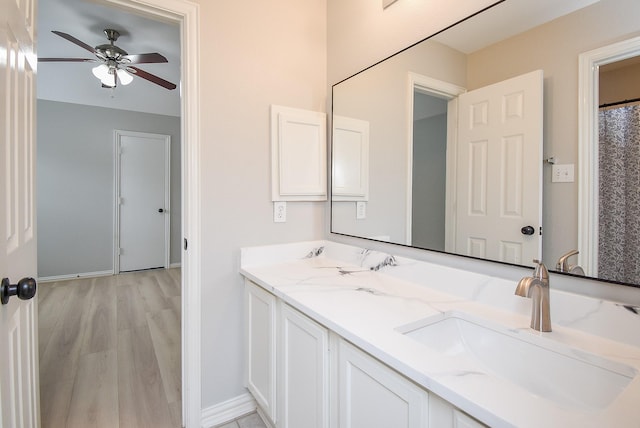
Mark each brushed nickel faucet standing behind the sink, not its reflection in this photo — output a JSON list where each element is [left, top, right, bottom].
[[515, 260, 551, 331]]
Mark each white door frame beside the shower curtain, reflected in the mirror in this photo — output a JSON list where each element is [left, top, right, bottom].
[[578, 37, 640, 276]]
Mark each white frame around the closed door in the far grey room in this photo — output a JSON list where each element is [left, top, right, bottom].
[[113, 129, 171, 275]]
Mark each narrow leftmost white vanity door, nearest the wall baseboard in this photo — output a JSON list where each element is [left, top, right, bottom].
[[245, 281, 276, 422]]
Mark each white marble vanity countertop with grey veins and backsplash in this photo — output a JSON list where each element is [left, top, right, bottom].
[[241, 241, 640, 427]]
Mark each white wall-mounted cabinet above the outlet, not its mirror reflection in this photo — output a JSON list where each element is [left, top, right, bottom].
[[271, 105, 327, 201]]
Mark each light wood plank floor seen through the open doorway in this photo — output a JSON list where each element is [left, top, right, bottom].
[[38, 269, 181, 428]]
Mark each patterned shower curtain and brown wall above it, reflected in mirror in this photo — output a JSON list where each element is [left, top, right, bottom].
[[595, 56, 640, 284]]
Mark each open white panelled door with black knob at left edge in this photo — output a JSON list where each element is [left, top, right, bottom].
[[0, 0, 40, 428]]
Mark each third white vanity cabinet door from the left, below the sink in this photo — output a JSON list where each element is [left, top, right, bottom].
[[338, 340, 428, 428]]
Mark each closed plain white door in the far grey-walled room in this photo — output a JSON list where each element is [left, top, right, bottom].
[[115, 131, 171, 272]]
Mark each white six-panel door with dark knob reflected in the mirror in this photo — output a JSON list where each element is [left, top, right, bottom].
[[455, 70, 543, 264]]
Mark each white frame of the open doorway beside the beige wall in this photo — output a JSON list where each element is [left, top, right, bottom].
[[101, 0, 202, 428]]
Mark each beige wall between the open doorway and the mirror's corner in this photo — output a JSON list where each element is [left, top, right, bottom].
[[198, 0, 327, 408]]
